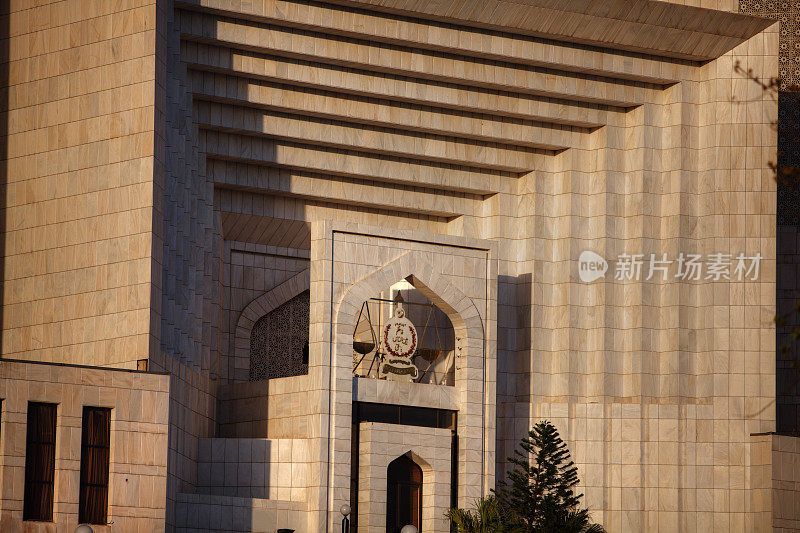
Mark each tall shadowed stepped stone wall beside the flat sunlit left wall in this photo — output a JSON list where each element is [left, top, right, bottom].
[[149, 5, 223, 530]]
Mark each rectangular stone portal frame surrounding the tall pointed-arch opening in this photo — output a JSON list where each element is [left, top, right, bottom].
[[309, 222, 497, 529]]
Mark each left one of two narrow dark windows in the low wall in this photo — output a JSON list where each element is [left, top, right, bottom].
[[22, 402, 56, 522]]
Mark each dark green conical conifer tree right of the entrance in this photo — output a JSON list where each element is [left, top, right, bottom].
[[495, 421, 603, 533]]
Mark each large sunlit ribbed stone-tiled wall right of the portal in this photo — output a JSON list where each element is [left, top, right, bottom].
[[497, 27, 777, 531]]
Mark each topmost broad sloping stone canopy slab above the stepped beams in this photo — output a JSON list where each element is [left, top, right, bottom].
[[318, 0, 774, 61]]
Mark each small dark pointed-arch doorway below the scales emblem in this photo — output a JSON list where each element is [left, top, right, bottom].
[[386, 455, 422, 533]]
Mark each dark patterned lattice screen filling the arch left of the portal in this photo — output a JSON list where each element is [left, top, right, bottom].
[[250, 291, 309, 381]]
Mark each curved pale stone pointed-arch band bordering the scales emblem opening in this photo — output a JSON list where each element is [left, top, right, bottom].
[[330, 251, 488, 528]]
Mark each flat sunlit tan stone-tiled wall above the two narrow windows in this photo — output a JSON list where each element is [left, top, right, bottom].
[[0, 0, 161, 368]]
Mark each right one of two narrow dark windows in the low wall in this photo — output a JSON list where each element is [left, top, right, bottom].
[[78, 407, 111, 524]]
